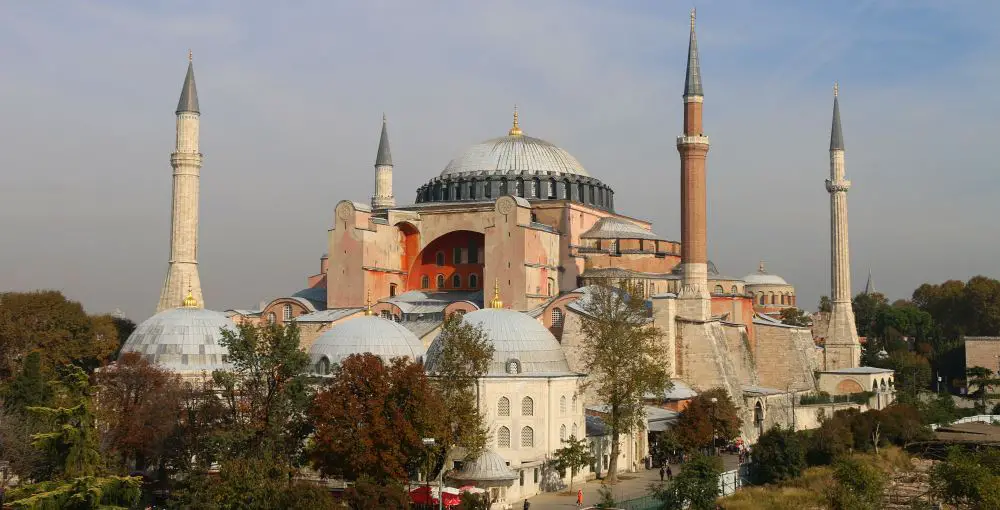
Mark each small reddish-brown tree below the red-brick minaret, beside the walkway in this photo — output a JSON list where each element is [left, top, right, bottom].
[[676, 388, 743, 451]]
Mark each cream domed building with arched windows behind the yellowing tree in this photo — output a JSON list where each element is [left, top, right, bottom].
[[427, 291, 589, 501]]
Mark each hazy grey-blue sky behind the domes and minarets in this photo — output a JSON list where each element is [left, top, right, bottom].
[[0, 0, 1000, 320]]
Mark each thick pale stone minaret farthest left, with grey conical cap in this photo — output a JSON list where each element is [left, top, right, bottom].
[[156, 52, 204, 312]]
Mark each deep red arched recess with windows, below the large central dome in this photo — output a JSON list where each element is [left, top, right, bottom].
[[405, 230, 486, 291]]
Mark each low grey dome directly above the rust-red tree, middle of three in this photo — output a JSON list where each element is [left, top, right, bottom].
[[309, 315, 424, 374]]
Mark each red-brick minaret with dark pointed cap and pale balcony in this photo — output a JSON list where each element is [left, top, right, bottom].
[[677, 9, 712, 320]]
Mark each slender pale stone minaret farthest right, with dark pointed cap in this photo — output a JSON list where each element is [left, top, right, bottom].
[[825, 84, 861, 370]]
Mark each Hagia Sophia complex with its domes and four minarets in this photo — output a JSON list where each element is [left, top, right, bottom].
[[123, 12, 893, 501]]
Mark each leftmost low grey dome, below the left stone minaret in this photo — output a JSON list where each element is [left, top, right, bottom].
[[119, 307, 236, 374]]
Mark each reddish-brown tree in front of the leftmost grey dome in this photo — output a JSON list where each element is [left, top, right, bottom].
[[95, 352, 184, 471]]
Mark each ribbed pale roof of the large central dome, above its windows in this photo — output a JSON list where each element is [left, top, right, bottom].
[[441, 134, 590, 177]]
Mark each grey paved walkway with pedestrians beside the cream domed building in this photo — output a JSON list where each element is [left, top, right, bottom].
[[511, 455, 739, 510]]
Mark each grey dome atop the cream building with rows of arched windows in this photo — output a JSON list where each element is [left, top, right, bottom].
[[427, 308, 572, 375]]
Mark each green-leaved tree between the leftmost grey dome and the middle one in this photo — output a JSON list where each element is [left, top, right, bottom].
[[212, 322, 313, 463]]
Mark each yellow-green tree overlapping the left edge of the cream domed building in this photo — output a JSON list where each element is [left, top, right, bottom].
[[427, 314, 495, 466]]
